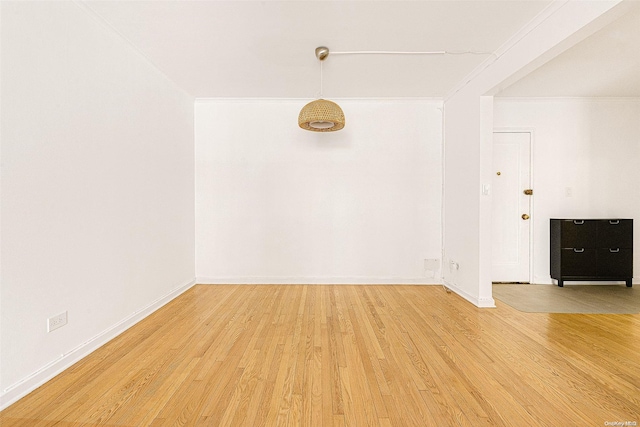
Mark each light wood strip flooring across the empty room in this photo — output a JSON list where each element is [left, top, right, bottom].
[[0, 285, 640, 427]]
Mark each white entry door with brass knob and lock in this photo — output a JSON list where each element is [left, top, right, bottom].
[[491, 132, 532, 283]]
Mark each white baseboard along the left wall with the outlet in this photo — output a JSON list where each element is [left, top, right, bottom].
[[0, 279, 196, 411]]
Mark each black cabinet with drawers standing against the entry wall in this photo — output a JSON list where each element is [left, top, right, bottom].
[[551, 218, 633, 287]]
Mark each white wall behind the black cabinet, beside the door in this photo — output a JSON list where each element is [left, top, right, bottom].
[[494, 98, 640, 283]]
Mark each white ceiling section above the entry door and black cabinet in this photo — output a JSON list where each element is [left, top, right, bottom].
[[497, 2, 640, 97]]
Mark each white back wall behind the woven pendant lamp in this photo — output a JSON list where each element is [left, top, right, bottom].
[[195, 100, 442, 283]]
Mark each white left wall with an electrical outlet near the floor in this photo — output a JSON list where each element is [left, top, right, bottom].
[[0, 2, 195, 406]]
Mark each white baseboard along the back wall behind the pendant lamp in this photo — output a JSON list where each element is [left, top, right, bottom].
[[196, 276, 442, 285]]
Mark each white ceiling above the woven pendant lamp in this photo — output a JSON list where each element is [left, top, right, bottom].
[[83, 0, 550, 98]]
